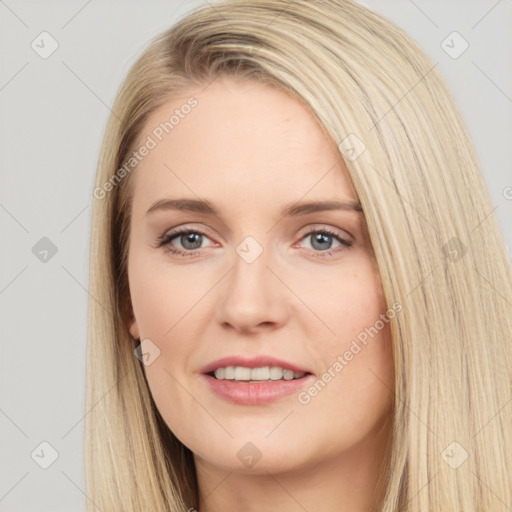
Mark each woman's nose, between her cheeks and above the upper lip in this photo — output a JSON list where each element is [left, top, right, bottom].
[[216, 242, 292, 334]]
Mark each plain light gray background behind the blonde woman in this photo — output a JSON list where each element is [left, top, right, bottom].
[[0, 0, 512, 512]]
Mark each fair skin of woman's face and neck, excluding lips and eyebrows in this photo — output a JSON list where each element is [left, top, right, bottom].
[[128, 77, 393, 512]]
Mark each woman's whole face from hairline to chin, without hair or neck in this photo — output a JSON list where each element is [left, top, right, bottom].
[[128, 77, 395, 472]]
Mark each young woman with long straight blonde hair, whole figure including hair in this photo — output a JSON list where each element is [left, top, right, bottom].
[[85, 0, 512, 512]]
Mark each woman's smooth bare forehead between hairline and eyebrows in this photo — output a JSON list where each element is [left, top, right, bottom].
[[133, 77, 356, 217]]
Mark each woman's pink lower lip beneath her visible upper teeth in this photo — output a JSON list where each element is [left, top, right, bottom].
[[203, 374, 314, 405]]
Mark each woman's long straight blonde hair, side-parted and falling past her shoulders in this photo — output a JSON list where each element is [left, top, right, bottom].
[[85, 0, 512, 512]]
